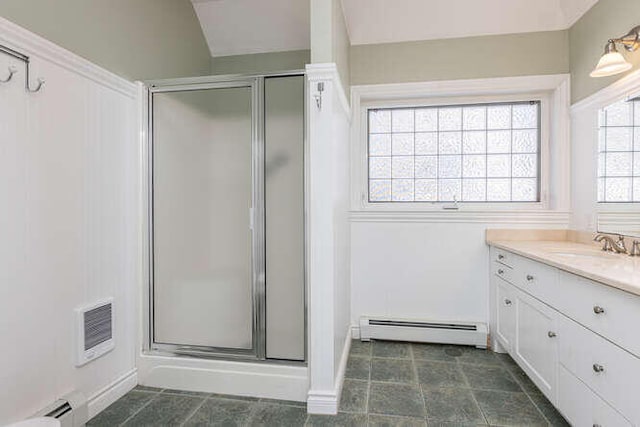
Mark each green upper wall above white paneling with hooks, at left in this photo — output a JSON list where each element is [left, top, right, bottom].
[[0, 0, 211, 80]]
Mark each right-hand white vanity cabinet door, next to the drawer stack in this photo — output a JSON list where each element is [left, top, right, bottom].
[[512, 291, 558, 403]]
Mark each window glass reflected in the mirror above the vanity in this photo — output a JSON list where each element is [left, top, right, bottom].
[[598, 99, 640, 203]]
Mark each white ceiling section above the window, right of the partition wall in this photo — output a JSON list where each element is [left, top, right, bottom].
[[342, 0, 598, 44]]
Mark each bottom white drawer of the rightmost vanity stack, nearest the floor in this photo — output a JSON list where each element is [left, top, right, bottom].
[[558, 365, 632, 427]]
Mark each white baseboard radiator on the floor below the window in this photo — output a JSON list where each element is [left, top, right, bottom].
[[360, 316, 488, 348]]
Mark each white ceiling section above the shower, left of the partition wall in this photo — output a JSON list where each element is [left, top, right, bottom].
[[191, 0, 309, 56]]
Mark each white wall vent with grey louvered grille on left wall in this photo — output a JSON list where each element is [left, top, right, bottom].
[[76, 298, 115, 366]]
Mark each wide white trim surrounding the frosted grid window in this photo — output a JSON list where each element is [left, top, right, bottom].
[[351, 74, 570, 217]]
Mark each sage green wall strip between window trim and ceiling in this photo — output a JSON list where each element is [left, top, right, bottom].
[[350, 30, 568, 85]]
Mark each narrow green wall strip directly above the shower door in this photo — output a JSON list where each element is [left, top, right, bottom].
[[211, 50, 311, 74]]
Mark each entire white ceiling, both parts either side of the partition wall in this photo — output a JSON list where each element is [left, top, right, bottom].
[[191, 0, 598, 56]]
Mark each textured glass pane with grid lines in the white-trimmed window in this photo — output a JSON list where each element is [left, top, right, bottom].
[[367, 101, 540, 202]]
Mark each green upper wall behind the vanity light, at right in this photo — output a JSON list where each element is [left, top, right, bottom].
[[569, 0, 640, 102]]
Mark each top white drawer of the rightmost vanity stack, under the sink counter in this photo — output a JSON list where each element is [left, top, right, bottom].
[[550, 271, 640, 357]]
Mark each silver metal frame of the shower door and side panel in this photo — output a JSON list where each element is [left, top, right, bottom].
[[141, 70, 308, 365]]
